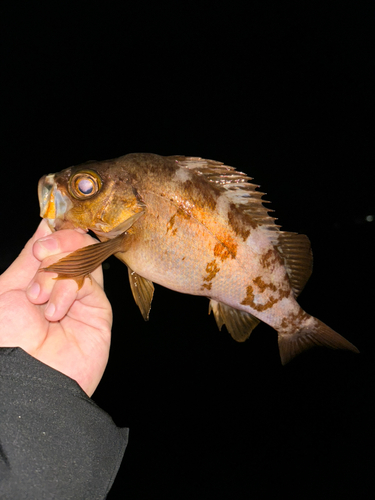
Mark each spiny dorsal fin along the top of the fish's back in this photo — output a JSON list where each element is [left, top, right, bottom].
[[169, 156, 280, 231]]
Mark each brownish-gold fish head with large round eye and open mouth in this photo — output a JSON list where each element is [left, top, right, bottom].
[[38, 160, 144, 237]]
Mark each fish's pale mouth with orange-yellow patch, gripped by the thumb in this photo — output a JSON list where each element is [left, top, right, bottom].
[[38, 174, 73, 231]]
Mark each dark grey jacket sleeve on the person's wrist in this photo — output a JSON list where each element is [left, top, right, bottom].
[[0, 348, 127, 500]]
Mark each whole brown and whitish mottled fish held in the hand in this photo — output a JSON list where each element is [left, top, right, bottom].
[[38, 153, 359, 365]]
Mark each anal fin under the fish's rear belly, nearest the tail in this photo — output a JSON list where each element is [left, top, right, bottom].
[[208, 300, 260, 342]]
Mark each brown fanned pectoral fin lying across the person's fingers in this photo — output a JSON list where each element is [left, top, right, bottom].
[[39, 233, 127, 290]]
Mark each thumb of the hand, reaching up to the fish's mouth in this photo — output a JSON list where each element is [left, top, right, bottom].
[[0, 219, 52, 292]]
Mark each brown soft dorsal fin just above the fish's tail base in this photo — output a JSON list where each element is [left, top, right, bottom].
[[275, 231, 313, 297]]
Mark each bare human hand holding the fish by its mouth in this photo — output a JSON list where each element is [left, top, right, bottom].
[[0, 220, 112, 396]]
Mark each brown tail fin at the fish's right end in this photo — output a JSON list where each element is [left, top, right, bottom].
[[278, 316, 359, 365]]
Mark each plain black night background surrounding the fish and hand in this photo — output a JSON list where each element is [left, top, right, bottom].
[[0, 0, 375, 500]]
